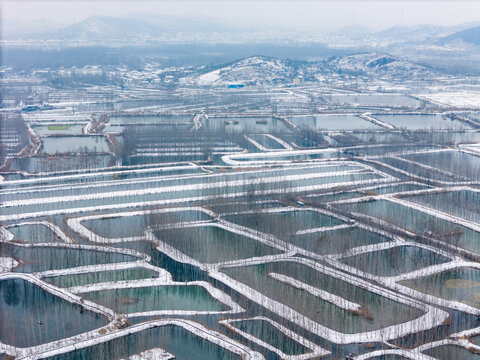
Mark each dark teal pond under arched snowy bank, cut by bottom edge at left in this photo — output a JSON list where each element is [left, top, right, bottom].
[[40, 325, 242, 360]]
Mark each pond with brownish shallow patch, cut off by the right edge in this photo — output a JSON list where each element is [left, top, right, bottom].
[[400, 268, 480, 309]]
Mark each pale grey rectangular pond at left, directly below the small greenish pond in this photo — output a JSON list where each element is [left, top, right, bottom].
[[41, 135, 110, 155]]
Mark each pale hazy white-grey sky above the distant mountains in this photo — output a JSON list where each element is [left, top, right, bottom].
[[0, 0, 480, 30]]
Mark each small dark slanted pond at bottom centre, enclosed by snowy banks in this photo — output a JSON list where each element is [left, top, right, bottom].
[[230, 319, 312, 355]]
